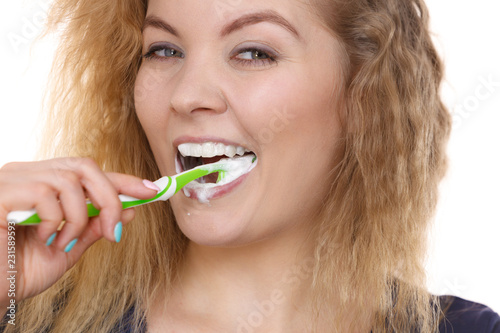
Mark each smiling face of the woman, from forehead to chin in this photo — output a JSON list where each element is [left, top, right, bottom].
[[135, 0, 341, 246]]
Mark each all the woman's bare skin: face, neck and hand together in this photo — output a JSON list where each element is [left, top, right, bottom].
[[0, 0, 352, 332]]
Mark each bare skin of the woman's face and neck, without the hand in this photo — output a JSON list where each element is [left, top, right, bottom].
[[135, 0, 350, 332]]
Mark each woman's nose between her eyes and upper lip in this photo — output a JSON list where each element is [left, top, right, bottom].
[[170, 59, 227, 115]]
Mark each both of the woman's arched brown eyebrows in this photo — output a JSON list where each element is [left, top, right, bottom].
[[142, 10, 300, 39]]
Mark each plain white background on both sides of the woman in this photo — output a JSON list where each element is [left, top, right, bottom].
[[0, 0, 500, 312]]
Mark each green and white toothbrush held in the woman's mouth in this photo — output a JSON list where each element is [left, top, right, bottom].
[[7, 158, 252, 225]]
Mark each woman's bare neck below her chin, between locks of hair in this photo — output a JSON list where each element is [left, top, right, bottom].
[[159, 222, 320, 332]]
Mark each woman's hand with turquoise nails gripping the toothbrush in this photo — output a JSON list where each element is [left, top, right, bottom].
[[0, 158, 157, 305]]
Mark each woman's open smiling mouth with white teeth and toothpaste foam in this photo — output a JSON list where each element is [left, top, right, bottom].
[[175, 142, 255, 203]]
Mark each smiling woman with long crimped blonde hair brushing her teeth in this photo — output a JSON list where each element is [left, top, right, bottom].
[[0, 0, 500, 332]]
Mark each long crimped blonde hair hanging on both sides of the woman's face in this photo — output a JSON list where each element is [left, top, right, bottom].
[[7, 0, 451, 333]]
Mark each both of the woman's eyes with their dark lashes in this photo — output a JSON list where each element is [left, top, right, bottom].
[[142, 45, 278, 67]]
